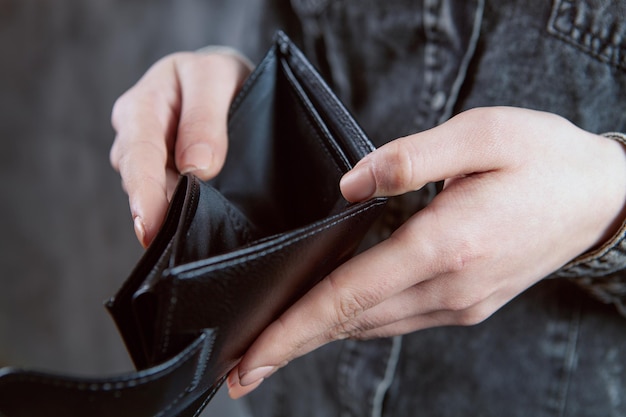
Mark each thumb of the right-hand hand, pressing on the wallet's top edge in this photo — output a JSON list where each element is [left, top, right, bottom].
[[341, 108, 510, 201]]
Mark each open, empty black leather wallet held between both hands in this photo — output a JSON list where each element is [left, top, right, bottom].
[[0, 32, 386, 417]]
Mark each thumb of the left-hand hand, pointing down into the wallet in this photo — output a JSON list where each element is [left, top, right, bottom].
[[175, 54, 250, 179]]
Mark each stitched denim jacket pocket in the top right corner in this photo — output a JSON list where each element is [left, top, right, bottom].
[[548, 0, 626, 70]]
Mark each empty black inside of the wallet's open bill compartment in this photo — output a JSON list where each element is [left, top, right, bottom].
[[174, 46, 359, 264]]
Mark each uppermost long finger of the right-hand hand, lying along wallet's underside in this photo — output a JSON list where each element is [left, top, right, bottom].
[[233, 239, 410, 385]]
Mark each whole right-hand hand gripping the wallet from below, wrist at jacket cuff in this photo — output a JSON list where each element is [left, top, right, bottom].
[[228, 108, 626, 398]]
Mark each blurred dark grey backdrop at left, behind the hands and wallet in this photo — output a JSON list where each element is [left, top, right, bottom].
[[0, 0, 268, 417]]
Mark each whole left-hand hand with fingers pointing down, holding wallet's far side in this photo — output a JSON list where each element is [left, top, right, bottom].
[[110, 48, 251, 247]]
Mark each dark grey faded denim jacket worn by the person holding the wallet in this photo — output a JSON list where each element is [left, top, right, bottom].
[[238, 0, 626, 417]]
